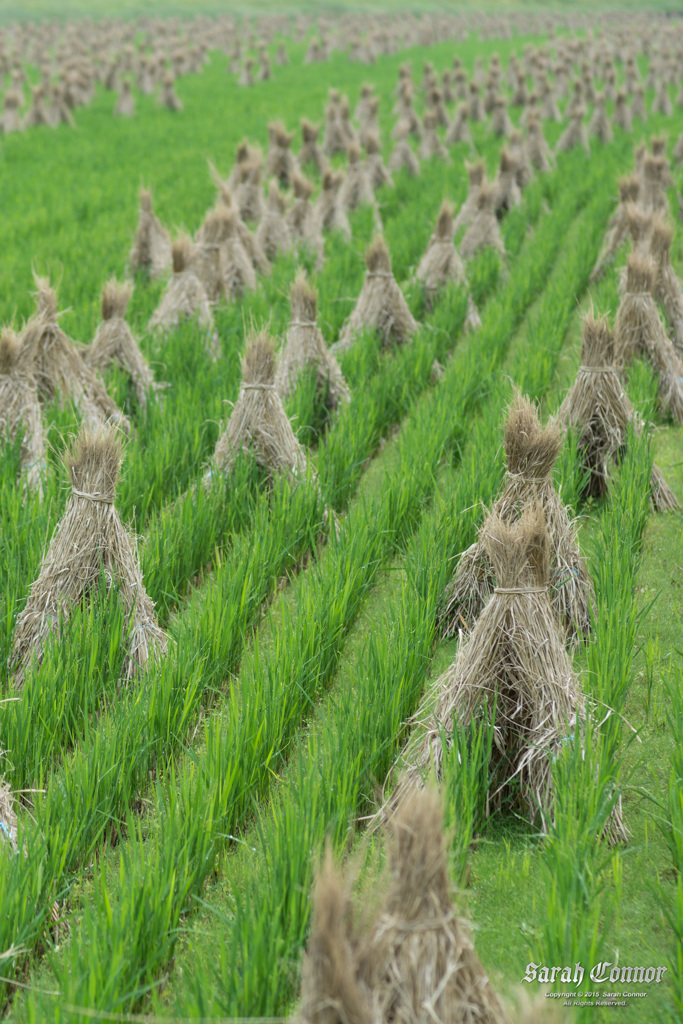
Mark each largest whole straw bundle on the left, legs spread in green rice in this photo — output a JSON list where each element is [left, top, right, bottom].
[[12, 427, 168, 687]]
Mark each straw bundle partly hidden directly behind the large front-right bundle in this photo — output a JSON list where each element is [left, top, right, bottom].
[[439, 392, 594, 641]]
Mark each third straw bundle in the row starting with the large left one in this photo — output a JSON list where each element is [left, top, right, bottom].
[[274, 270, 350, 410]]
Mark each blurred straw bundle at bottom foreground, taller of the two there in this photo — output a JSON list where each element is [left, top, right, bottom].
[[358, 787, 509, 1024]]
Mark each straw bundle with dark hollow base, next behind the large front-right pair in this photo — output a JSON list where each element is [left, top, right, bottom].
[[554, 312, 678, 511]]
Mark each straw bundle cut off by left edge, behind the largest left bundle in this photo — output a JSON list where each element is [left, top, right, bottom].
[[0, 327, 46, 495]]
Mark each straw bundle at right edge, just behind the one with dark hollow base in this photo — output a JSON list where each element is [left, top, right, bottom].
[[614, 252, 683, 423]]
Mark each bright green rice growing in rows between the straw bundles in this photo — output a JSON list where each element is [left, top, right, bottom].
[[0, 8, 683, 1022]]
